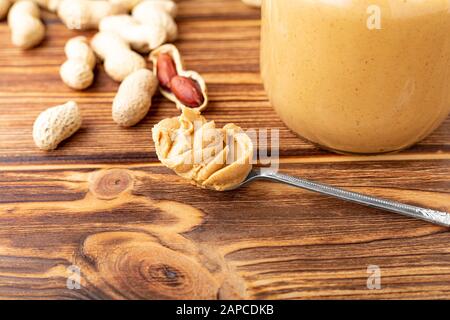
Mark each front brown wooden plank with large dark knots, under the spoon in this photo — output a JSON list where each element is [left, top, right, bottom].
[[0, 160, 450, 299]]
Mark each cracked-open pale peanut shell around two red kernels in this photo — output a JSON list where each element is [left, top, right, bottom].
[[150, 44, 208, 111]]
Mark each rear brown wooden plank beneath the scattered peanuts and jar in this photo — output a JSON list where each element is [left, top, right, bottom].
[[0, 0, 450, 163]]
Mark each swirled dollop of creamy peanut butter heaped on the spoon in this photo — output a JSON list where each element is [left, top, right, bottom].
[[152, 108, 253, 191]]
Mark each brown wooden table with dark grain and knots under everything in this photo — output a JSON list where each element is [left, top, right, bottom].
[[0, 0, 450, 299]]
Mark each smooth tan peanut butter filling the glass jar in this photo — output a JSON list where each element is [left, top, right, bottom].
[[261, 0, 450, 153]]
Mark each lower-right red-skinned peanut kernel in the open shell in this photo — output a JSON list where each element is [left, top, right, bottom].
[[170, 75, 205, 108]]
